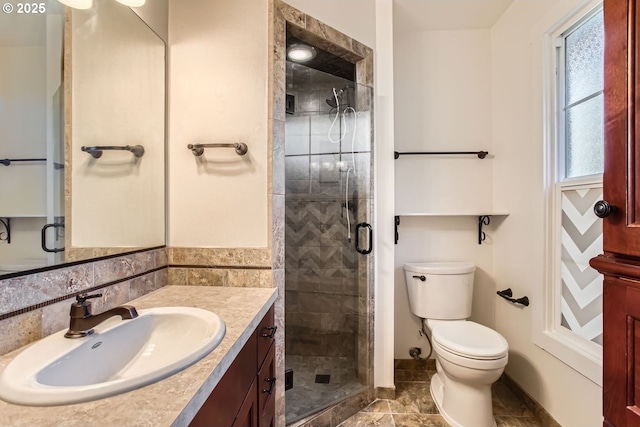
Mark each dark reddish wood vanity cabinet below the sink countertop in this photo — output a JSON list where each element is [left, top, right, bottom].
[[189, 307, 276, 427]]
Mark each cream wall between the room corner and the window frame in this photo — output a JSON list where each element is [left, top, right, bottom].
[[491, 0, 602, 426]]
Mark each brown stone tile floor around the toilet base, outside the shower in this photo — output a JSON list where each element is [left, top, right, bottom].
[[339, 360, 543, 427]]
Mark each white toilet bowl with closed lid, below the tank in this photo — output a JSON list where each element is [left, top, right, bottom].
[[430, 321, 509, 427]]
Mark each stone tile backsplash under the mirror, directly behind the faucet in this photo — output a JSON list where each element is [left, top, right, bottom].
[[0, 248, 168, 355]]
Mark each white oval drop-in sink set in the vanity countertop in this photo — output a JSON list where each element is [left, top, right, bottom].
[[0, 307, 225, 406]]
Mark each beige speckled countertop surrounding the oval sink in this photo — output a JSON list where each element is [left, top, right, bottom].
[[0, 286, 276, 427]]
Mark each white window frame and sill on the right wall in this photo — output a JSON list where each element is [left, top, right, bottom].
[[533, 0, 602, 386]]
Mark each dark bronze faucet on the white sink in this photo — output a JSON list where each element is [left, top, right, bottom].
[[64, 294, 138, 338]]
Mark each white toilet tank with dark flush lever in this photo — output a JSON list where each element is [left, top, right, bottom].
[[404, 262, 476, 320]]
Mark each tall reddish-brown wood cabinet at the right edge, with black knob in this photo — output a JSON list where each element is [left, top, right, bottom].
[[591, 0, 640, 427]]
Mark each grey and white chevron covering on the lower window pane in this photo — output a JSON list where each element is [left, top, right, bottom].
[[561, 185, 602, 345]]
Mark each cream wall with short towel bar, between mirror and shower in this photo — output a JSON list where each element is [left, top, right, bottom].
[[168, 0, 270, 248]]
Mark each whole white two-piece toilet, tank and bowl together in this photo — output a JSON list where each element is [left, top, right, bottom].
[[404, 262, 509, 427]]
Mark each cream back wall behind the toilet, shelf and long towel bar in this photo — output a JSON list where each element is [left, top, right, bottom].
[[394, 28, 500, 359]]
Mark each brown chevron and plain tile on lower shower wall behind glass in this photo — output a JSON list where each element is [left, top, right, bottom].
[[285, 200, 357, 357]]
